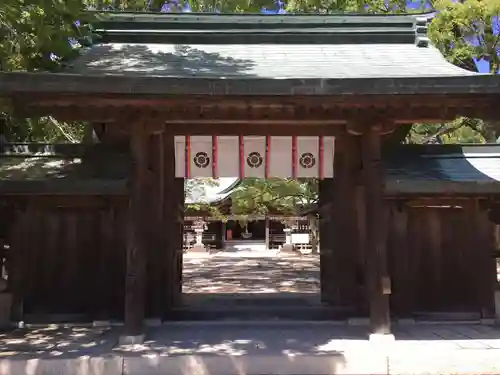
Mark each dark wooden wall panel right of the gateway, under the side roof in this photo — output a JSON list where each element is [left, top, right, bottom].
[[387, 200, 495, 317]]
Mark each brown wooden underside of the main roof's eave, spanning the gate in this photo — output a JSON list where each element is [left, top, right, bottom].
[[15, 95, 498, 125]]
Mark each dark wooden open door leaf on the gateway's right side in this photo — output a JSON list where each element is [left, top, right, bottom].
[[319, 135, 361, 312]]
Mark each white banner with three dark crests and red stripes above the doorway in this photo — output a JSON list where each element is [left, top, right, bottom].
[[175, 136, 335, 178]]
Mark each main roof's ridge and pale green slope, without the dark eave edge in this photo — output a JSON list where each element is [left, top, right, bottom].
[[56, 13, 472, 79]]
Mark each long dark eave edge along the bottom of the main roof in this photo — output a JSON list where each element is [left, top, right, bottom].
[[0, 72, 500, 98]]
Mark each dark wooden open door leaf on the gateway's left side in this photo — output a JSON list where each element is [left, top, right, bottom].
[[146, 133, 184, 318]]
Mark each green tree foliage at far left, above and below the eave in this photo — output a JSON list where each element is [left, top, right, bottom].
[[0, 0, 92, 142]]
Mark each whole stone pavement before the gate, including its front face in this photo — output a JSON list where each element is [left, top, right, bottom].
[[4, 322, 500, 375]]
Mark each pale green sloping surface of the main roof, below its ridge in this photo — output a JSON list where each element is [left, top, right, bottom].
[[67, 43, 473, 79]]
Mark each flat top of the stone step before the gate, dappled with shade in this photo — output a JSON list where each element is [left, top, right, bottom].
[[0, 322, 500, 361]]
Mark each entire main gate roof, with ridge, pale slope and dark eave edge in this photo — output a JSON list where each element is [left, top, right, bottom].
[[0, 13, 500, 96]]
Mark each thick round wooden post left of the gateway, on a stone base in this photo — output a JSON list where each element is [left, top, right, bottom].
[[121, 122, 148, 343]]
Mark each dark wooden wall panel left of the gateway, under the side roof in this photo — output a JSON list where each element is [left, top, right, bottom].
[[9, 198, 126, 319]]
